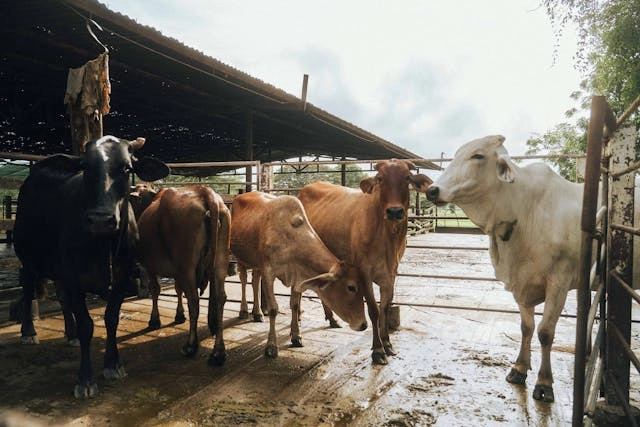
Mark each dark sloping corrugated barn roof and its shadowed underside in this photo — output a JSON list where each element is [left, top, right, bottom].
[[0, 0, 437, 174]]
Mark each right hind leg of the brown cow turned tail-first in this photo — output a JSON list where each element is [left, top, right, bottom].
[[208, 270, 228, 366]]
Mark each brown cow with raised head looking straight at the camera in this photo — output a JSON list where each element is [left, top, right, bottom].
[[298, 159, 432, 365]]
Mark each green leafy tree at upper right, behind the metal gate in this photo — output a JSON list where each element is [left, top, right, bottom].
[[527, 0, 640, 163]]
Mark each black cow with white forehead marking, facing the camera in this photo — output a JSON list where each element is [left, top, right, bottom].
[[14, 136, 169, 398]]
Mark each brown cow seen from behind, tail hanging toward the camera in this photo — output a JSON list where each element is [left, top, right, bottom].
[[138, 185, 231, 365]]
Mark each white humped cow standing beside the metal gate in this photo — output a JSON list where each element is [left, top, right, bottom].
[[427, 135, 583, 402]]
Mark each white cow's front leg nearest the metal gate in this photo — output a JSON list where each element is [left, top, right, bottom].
[[533, 285, 567, 402]]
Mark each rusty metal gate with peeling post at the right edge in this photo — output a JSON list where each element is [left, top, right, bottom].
[[572, 96, 640, 426]]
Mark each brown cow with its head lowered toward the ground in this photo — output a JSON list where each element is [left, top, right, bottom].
[[231, 192, 367, 357]]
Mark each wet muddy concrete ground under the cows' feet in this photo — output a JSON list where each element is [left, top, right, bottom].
[[0, 234, 640, 426]]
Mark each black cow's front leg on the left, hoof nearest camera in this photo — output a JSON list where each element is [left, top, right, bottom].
[[69, 290, 98, 399]]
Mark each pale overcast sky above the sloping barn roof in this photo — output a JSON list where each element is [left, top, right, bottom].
[[102, 0, 581, 158]]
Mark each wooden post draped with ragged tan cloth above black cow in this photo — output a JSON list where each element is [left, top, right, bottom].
[[64, 52, 111, 154]]
